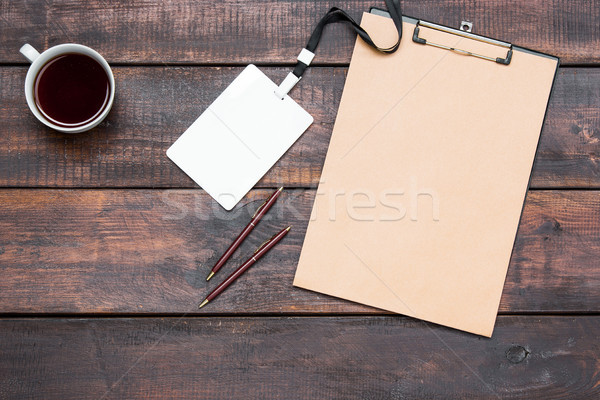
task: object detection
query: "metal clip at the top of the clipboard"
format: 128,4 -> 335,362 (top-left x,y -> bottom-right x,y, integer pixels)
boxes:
413,20 -> 512,65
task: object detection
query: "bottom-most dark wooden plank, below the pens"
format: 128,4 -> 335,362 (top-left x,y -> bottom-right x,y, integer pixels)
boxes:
0,316 -> 600,400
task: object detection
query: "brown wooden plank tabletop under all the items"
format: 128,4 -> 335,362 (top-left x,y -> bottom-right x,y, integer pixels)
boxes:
0,0 -> 600,399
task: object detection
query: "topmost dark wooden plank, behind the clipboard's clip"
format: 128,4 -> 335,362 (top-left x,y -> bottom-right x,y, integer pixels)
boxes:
0,0 -> 600,64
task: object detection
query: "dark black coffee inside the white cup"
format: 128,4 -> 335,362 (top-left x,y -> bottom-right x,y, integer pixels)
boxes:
34,53 -> 111,127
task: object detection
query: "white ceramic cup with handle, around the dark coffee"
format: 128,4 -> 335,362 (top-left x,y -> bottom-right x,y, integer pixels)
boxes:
20,43 -> 115,133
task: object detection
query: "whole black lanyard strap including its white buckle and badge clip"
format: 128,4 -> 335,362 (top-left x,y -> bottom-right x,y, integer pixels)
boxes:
275,0 -> 402,99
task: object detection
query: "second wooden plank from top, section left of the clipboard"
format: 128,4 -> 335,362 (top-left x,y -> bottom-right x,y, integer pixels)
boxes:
0,67 -> 346,187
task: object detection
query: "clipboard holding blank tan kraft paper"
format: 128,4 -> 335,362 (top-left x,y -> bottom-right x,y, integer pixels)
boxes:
294,9 -> 559,337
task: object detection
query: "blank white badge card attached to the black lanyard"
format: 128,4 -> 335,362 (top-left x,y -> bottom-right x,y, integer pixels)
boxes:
167,65 -> 313,210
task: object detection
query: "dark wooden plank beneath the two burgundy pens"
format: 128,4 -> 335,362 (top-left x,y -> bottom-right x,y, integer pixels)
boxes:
0,189 -> 600,314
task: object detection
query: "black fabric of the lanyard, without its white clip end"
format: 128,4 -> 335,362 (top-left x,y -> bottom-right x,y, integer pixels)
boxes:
292,0 -> 402,79
